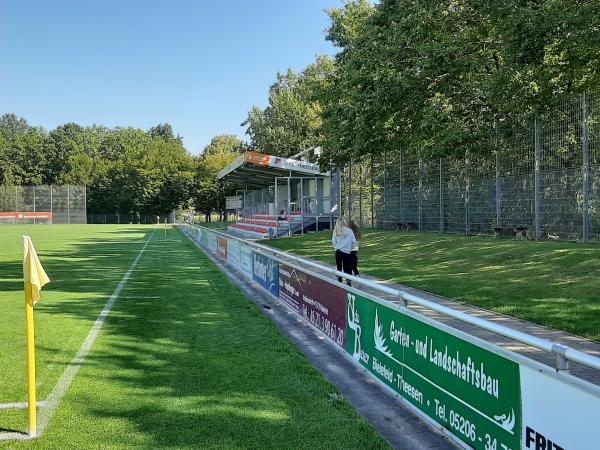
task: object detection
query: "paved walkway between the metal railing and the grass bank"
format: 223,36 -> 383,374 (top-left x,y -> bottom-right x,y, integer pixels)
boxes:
258,241 -> 600,385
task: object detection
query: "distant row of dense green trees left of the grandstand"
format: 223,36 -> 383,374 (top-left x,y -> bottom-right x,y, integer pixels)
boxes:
0,114 -> 195,214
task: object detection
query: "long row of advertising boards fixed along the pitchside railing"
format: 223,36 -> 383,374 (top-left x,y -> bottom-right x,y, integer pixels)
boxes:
185,229 -> 600,450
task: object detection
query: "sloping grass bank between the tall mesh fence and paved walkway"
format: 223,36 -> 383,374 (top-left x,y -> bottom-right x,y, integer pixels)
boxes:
264,230 -> 600,341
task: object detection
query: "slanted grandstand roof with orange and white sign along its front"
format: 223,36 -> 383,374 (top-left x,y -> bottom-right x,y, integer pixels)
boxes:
219,152 -> 321,187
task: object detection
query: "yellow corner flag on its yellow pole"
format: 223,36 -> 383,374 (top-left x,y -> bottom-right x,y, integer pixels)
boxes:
23,236 -> 50,437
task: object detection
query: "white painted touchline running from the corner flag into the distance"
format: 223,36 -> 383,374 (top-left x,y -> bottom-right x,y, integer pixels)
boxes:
0,228 -> 156,441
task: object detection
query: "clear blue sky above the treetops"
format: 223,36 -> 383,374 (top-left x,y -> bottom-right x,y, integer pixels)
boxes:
0,0 -> 342,153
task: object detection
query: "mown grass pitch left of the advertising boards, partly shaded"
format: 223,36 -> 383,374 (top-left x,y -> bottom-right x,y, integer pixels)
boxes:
0,225 -> 386,449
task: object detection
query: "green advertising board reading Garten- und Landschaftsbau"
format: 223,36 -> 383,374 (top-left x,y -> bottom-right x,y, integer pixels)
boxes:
346,292 -> 521,450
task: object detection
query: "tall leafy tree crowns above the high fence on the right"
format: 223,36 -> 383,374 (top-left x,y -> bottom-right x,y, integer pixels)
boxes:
245,0 -> 600,163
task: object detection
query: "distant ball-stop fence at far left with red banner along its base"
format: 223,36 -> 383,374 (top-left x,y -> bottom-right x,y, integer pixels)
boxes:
0,185 -> 86,224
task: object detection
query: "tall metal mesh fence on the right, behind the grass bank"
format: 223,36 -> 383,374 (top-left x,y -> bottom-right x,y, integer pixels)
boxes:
341,92 -> 600,241
